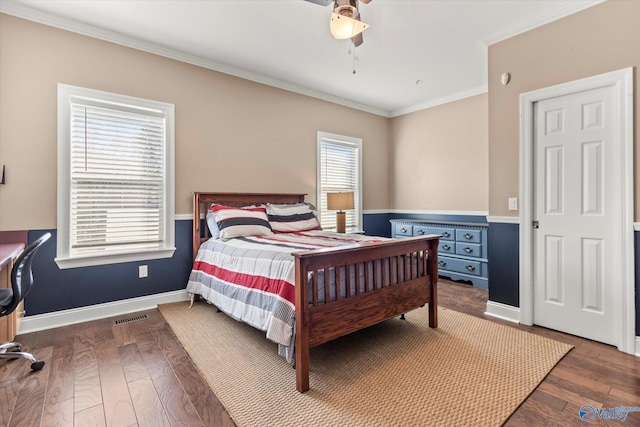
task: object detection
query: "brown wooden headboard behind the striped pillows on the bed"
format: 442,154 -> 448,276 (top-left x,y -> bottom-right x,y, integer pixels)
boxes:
193,192 -> 306,259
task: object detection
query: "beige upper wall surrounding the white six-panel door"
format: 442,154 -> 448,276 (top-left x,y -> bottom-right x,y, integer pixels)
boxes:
489,0 -> 640,221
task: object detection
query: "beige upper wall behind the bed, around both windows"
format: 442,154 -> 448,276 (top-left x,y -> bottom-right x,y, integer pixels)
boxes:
0,14 -> 390,230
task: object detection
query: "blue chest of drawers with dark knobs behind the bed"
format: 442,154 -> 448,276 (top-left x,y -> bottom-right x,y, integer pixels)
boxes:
391,219 -> 489,289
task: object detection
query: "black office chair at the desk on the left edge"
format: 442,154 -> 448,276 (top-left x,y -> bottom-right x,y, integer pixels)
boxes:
0,233 -> 51,371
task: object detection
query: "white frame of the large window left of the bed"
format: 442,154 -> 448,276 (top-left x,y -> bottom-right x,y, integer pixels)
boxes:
55,83 -> 176,269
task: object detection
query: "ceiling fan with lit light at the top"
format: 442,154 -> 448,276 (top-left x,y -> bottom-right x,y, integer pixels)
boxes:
305,0 -> 371,46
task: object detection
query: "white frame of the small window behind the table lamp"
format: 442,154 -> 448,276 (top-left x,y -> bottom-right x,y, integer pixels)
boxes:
316,131 -> 363,233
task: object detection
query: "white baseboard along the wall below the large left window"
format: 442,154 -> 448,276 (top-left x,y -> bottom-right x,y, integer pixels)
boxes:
18,290 -> 189,334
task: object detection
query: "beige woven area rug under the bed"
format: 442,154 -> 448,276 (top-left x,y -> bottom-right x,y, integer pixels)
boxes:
159,302 -> 572,427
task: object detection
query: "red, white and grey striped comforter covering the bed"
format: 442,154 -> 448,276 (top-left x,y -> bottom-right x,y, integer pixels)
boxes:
187,230 -> 382,362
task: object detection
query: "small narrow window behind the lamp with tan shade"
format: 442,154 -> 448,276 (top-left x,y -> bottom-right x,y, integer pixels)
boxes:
317,132 -> 362,231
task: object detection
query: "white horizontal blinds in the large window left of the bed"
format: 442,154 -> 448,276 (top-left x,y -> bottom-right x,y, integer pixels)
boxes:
71,102 -> 164,255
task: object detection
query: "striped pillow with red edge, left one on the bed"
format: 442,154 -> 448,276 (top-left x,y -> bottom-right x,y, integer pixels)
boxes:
211,204 -> 273,240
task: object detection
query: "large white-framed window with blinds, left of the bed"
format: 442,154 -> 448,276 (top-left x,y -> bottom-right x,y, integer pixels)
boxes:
56,84 -> 175,268
